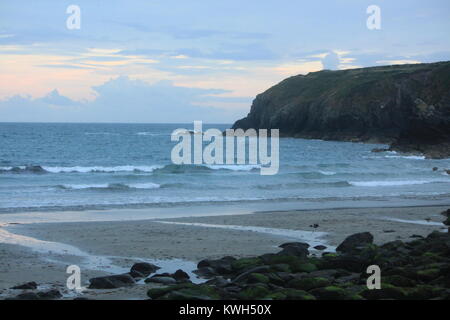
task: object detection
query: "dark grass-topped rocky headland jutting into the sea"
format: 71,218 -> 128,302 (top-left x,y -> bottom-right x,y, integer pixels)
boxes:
233,62 -> 450,157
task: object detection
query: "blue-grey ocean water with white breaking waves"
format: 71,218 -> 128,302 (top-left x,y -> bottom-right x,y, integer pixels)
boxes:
0,123 -> 450,213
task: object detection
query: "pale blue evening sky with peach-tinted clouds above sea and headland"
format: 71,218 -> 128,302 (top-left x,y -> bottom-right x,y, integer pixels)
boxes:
0,0 -> 450,123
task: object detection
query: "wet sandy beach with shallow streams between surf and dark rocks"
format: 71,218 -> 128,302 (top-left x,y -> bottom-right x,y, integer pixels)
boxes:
0,206 -> 448,299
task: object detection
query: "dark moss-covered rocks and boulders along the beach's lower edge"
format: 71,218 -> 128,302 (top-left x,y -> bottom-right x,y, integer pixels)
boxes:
9,209 -> 450,300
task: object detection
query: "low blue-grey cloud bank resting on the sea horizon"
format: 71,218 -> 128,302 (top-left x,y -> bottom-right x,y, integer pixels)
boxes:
0,76 -> 249,123
